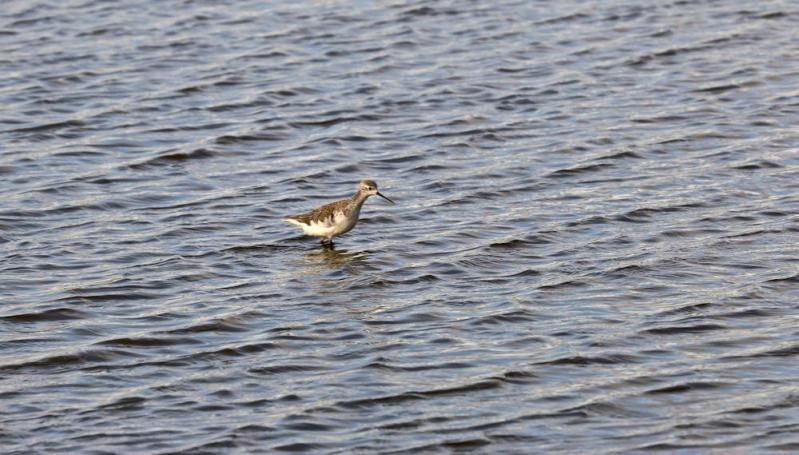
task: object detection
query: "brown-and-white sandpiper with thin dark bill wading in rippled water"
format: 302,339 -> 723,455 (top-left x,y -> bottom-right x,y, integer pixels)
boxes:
284,180 -> 394,246
